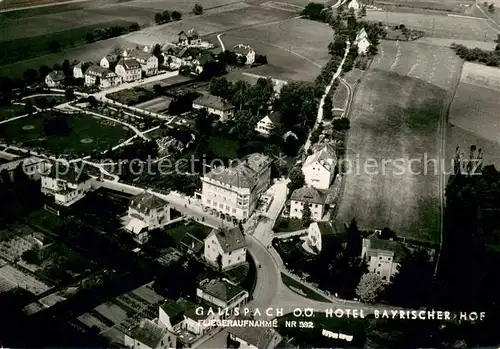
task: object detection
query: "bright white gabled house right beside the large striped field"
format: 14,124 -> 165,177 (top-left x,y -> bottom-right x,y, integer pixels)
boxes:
302,144 -> 337,190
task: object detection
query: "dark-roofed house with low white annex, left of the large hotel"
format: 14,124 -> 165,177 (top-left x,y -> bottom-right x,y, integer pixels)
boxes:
125,192 -> 170,244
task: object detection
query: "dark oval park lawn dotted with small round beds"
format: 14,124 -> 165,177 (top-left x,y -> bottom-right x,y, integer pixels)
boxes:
0,114 -> 131,153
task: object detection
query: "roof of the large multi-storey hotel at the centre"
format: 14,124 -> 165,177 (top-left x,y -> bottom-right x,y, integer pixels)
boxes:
207,153 -> 272,188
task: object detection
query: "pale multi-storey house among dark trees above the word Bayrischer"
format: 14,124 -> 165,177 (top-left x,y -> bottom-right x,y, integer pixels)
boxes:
361,232 -> 408,283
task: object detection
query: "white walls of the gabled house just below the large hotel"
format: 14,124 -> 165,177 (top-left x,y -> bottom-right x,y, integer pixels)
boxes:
203,230 -> 247,270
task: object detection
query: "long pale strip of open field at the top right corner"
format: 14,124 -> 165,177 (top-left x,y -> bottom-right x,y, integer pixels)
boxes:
365,11 -> 497,41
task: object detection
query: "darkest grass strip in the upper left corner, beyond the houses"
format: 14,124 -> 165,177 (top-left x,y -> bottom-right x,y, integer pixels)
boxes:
0,20 -> 132,64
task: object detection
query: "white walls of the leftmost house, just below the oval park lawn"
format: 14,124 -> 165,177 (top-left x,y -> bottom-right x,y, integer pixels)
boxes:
41,175 -> 92,206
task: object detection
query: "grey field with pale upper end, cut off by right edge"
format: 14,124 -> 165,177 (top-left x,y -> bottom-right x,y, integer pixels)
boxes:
448,62 -> 500,167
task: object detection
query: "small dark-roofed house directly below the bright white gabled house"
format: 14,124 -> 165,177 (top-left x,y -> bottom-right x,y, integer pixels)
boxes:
290,185 -> 326,221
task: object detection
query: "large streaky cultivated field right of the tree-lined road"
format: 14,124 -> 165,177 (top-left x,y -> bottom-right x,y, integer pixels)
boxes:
338,42 -> 460,241
